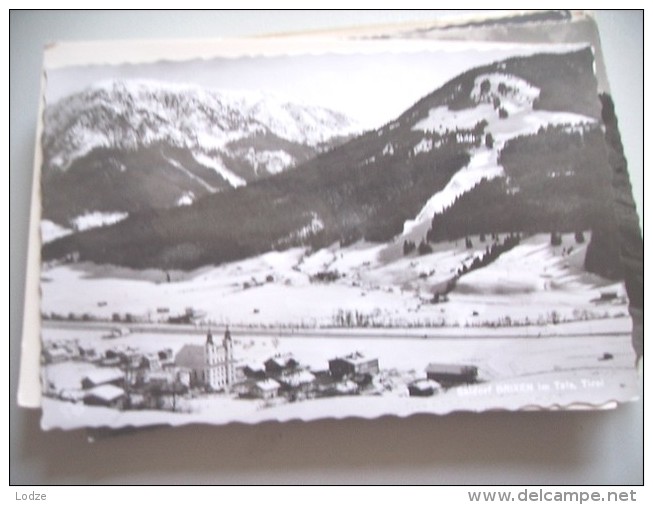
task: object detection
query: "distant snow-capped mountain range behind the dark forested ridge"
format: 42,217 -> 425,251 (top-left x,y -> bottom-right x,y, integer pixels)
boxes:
43,80 -> 360,224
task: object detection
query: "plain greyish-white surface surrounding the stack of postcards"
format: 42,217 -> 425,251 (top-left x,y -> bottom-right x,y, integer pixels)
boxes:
9,11 -> 643,484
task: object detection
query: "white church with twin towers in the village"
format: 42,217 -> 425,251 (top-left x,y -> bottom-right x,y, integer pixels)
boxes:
175,327 -> 235,391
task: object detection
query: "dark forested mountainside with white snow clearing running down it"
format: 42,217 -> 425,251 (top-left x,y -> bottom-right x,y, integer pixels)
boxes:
44,50 -> 610,278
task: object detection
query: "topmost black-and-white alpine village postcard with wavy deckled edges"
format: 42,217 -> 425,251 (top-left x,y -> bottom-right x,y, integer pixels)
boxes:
33,38 -> 643,429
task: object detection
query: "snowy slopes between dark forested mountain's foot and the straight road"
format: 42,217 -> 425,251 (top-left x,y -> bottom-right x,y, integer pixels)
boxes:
41,234 -> 631,334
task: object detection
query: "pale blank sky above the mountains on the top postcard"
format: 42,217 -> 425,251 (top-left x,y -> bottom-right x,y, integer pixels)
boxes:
46,41 -> 579,128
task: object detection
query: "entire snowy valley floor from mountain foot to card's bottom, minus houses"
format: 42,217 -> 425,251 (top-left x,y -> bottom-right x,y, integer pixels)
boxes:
41,228 -> 637,429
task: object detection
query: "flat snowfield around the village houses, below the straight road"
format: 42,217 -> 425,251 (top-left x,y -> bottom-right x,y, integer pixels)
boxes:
42,325 -> 637,429
